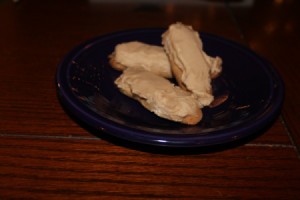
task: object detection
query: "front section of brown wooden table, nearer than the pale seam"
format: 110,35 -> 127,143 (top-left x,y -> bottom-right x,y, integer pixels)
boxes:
0,137 -> 300,198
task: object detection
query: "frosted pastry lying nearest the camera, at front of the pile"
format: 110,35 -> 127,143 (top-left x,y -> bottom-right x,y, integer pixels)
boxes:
115,68 -> 202,125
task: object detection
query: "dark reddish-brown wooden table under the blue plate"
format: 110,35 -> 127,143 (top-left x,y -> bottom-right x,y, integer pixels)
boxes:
0,0 -> 300,199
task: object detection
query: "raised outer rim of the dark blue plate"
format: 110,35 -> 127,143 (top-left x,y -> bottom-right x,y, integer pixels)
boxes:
55,28 -> 284,147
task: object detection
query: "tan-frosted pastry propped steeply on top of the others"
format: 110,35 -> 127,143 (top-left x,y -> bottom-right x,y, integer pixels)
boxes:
162,23 -> 217,107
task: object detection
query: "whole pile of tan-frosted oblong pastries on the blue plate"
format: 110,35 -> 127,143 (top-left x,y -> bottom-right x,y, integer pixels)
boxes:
109,23 -> 222,125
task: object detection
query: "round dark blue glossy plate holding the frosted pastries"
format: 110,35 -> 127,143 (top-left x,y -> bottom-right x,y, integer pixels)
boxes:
56,29 -> 284,147
